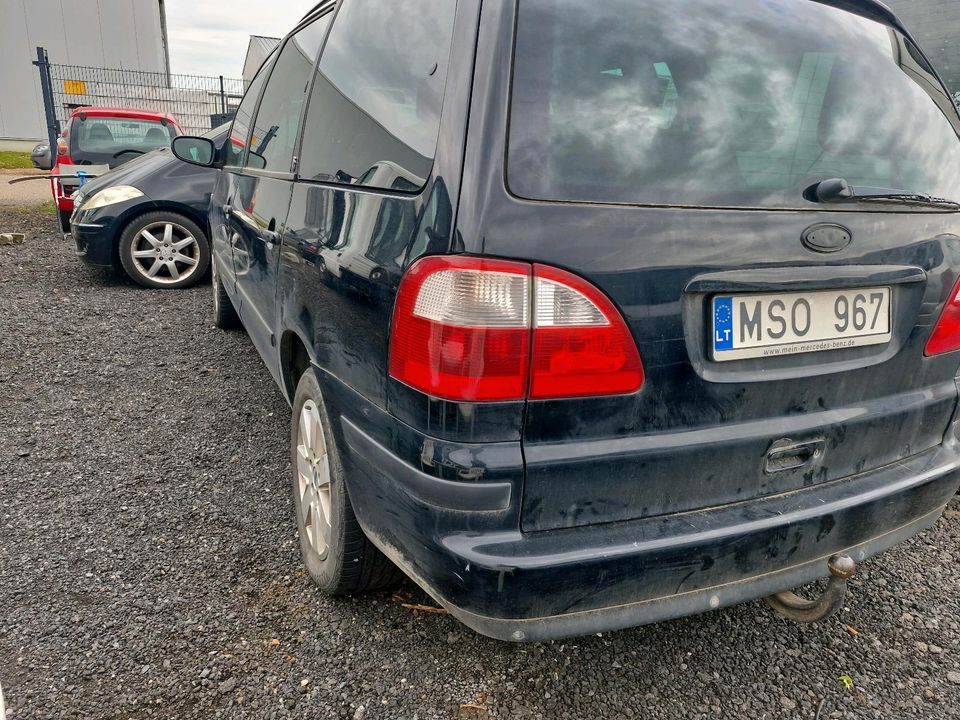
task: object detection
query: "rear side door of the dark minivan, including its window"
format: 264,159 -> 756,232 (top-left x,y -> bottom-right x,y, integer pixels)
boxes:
225,13 -> 330,374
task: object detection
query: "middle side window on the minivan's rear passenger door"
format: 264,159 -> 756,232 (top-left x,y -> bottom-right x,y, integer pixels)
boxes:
245,14 -> 331,172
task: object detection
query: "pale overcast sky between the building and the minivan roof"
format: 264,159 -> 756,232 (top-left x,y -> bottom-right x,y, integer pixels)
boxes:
166,0 -> 317,78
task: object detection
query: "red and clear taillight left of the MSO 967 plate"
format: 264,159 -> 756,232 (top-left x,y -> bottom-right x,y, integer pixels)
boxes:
390,256 -> 643,402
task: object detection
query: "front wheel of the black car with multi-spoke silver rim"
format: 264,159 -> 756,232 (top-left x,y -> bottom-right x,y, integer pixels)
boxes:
118,210 -> 210,290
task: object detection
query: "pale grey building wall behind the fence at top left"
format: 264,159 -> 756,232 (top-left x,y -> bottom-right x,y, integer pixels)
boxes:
0,0 -> 168,139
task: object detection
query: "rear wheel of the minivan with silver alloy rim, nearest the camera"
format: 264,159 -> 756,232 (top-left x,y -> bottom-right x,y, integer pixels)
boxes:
290,370 -> 403,595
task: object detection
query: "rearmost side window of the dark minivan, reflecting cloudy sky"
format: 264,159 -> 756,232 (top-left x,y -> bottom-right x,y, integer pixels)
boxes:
300,0 -> 456,189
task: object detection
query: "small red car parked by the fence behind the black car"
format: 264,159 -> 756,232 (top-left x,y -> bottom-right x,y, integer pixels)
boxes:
51,107 -> 183,232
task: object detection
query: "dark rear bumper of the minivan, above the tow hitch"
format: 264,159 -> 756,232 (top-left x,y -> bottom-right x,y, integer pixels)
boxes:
335,372 -> 960,641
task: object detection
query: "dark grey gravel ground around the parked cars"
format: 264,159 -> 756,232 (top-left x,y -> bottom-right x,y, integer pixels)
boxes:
0,204 -> 960,720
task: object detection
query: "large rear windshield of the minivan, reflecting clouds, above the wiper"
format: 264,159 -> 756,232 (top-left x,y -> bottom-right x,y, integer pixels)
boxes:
508,0 -> 960,208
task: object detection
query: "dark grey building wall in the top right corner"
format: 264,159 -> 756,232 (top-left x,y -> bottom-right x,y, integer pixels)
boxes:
886,0 -> 960,92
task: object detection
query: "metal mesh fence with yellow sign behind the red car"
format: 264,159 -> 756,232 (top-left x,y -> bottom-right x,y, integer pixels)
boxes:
40,56 -> 245,134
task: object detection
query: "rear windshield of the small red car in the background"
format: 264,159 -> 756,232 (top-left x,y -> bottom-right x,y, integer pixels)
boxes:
70,117 -> 176,162
